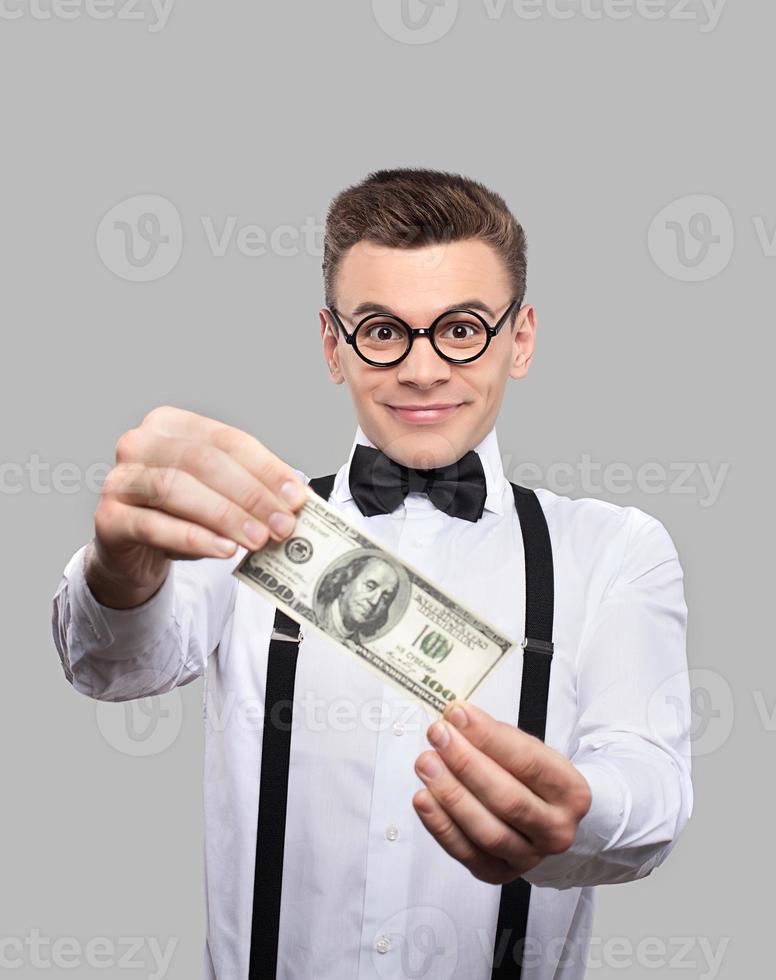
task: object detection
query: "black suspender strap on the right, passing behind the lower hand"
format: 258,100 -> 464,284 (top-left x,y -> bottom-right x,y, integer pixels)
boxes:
491,483 -> 554,980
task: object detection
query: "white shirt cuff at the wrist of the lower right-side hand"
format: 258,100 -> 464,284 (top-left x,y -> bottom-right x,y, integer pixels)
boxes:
522,762 -> 630,888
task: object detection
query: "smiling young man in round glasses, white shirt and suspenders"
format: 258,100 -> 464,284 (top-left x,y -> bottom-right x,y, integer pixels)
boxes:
54,170 -> 692,980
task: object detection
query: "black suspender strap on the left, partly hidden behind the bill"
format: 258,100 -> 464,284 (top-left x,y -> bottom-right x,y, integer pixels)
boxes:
248,474 -> 336,980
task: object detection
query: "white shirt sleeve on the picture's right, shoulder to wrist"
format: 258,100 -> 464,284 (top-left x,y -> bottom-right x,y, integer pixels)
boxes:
523,508 -> 693,889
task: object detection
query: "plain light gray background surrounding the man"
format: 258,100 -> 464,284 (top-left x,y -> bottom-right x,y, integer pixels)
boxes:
0,0 -> 776,980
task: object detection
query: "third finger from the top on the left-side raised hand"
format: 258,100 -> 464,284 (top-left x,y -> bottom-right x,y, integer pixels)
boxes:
104,464 -> 278,551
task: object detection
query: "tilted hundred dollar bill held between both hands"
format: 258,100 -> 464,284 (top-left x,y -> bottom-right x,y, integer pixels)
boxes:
233,487 -> 515,712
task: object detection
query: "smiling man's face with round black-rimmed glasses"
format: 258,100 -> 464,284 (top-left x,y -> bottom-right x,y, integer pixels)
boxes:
320,239 -> 536,469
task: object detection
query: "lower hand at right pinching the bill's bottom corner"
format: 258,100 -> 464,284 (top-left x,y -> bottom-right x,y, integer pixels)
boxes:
412,701 -> 592,885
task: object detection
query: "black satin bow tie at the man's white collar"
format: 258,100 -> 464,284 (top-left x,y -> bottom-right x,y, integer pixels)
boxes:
348,444 -> 487,521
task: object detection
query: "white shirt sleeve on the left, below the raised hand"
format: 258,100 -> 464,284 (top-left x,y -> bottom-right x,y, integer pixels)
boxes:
52,470 -> 307,701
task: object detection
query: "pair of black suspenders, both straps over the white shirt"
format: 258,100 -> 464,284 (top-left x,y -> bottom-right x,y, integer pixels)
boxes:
248,474 -> 554,980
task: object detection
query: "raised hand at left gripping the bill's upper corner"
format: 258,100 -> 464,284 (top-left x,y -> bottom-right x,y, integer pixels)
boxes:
85,406 -> 307,609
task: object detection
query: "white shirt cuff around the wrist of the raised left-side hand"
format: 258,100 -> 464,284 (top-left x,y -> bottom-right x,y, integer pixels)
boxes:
64,545 -> 175,659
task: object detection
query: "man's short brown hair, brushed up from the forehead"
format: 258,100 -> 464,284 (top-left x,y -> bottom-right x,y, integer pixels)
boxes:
323,167 -> 526,325
